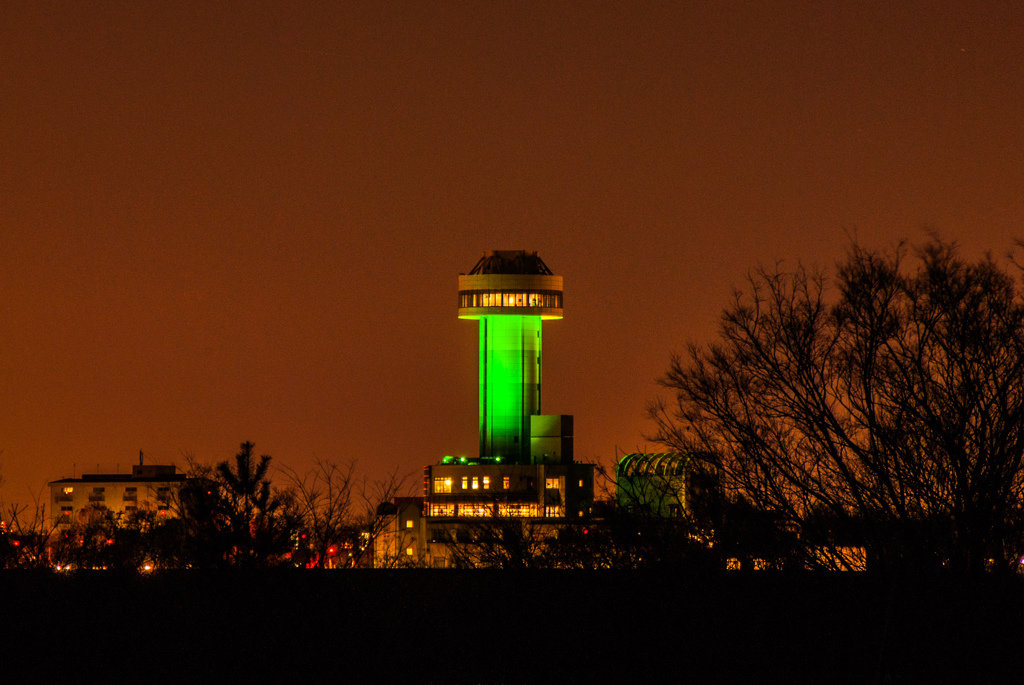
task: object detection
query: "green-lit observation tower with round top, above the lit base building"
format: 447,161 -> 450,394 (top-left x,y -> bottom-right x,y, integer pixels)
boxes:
459,250 -> 572,464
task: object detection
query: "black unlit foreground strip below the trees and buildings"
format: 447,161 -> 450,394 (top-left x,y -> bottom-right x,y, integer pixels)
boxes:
0,570 -> 1024,683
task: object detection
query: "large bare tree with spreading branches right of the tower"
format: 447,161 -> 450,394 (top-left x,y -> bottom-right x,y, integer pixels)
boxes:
651,238 -> 1024,571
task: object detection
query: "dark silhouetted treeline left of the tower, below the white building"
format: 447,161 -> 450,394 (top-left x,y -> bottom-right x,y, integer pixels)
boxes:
0,442 -> 402,571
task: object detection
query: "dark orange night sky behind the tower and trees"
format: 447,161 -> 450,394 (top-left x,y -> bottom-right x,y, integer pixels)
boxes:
0,0 -> 1024,503
